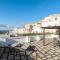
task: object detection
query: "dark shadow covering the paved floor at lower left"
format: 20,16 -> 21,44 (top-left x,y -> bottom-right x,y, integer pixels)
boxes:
0,46 -> 35,60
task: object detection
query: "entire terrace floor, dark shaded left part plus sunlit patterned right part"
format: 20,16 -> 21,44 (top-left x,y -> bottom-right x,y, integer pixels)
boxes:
0,40 -> 60,60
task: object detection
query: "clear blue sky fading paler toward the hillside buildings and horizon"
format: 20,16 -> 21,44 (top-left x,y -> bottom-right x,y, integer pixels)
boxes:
0,0 -> 60,29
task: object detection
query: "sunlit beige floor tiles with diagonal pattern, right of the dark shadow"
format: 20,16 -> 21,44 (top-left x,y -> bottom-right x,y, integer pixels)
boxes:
32,41 -> 60,60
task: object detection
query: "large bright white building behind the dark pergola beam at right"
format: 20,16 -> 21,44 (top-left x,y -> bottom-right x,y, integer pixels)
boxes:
41,14 -> 60,33
